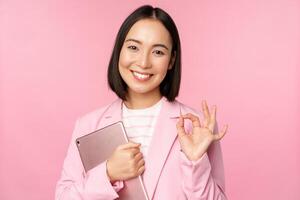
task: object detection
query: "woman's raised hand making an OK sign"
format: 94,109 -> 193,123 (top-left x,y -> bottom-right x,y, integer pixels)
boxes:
176,101 -> 228,161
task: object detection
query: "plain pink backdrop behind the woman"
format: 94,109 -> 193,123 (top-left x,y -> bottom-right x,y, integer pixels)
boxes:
0,0 -> 300,200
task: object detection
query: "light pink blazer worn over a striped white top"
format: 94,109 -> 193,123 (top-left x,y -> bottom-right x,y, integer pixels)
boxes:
55,97 -> 227,200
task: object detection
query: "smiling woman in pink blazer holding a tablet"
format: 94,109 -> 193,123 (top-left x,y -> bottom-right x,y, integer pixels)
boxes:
56,6 -> 227,200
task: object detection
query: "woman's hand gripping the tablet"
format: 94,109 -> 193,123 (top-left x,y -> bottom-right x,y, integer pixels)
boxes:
106,142 -> 145,183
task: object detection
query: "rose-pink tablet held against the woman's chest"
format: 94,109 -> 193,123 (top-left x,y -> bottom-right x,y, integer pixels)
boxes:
76,121 -> 148,200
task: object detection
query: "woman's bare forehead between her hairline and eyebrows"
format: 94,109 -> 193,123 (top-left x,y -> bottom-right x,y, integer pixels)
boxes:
125,19 -> 172,45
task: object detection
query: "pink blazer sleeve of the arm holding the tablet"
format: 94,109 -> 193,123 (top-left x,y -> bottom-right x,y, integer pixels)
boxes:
55,119 -> 123,200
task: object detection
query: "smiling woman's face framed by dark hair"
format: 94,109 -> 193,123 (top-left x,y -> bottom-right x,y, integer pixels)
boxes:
119,19 -> 175,97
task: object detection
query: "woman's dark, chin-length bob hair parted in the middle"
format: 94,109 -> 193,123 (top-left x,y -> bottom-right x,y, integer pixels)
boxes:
107,5 -> 181,102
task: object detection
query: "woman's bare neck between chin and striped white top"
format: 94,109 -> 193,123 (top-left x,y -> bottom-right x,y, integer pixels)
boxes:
124,93 -> 162,109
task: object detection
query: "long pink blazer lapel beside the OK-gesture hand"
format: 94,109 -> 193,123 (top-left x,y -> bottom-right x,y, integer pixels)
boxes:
143,97 -> 181,199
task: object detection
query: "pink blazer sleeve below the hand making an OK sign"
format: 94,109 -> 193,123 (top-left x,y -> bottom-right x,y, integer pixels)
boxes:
180,121 -> 227,200
